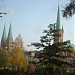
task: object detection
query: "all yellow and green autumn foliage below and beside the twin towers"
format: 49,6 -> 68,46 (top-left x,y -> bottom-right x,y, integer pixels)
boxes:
0,34 -> 27,69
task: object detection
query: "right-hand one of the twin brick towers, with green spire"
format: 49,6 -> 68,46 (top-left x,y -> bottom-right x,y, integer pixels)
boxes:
7,23 -> 13,50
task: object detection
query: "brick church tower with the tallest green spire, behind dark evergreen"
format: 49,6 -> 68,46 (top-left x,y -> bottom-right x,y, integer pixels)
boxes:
54,5 -> 64,43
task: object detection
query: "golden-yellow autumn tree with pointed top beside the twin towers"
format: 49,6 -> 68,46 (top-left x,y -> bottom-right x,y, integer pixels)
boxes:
11,35 -> 27,69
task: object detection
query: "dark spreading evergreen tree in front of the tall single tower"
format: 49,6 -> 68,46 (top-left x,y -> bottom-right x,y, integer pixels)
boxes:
31,24 -> 73,68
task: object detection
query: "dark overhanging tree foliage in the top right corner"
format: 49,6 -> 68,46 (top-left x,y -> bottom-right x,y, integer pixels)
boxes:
62,0 -> 75,17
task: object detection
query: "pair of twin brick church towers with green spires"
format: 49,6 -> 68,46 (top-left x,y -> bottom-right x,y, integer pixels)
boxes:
1,24 -> 13,50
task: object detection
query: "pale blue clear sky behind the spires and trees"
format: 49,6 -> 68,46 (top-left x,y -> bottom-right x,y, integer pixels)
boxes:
0,0 -> 75,50
